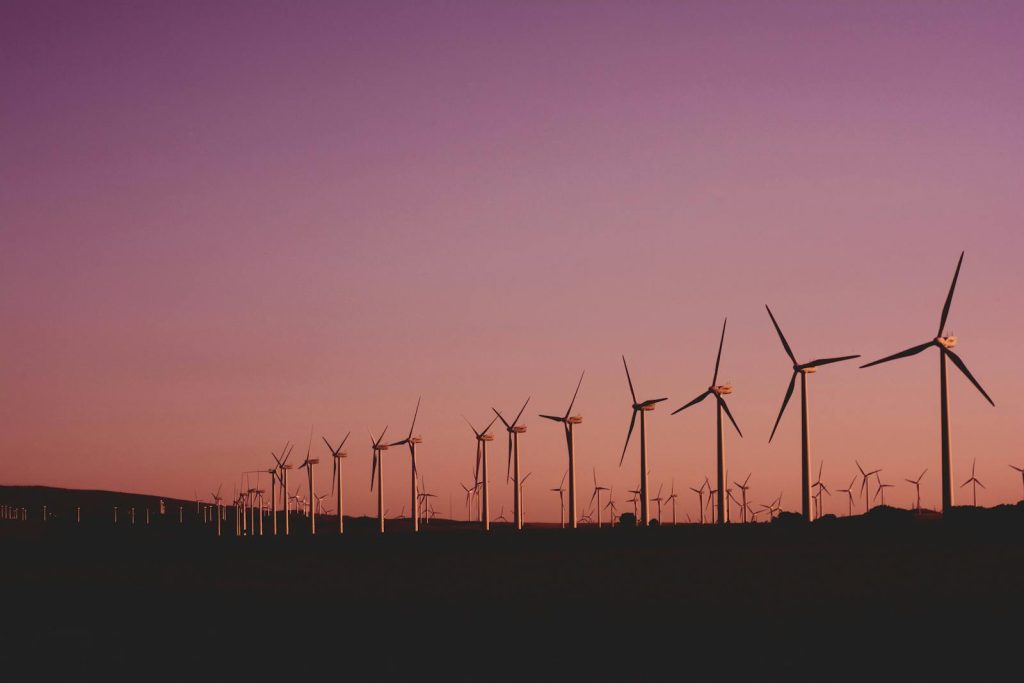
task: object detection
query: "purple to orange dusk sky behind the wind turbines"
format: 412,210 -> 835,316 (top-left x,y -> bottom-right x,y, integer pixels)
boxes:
0,1 -> 1024,521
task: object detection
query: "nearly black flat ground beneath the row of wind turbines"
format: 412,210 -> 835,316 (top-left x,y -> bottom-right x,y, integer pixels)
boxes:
0,489 -> 1024,680
